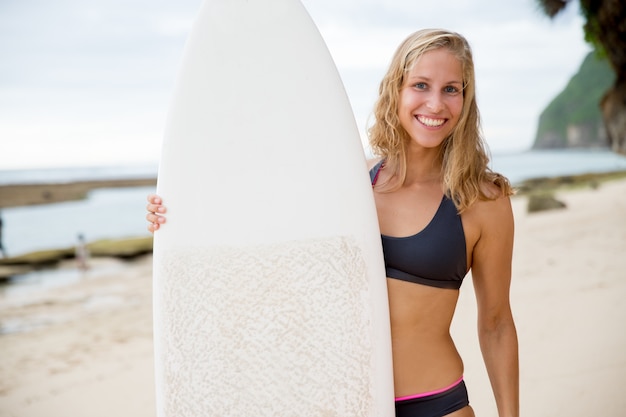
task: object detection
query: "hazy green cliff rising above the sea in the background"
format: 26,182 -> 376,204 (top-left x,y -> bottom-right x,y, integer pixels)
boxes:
532,51 -> 615,149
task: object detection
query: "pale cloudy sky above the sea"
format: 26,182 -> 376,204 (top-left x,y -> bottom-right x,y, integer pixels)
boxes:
0,0 -> 591,171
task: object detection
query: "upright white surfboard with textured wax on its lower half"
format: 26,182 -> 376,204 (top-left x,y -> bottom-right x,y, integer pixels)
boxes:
153,0 -> 394,417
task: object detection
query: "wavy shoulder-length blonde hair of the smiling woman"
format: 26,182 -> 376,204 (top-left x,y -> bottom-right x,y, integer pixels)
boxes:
369,29 -> 514,212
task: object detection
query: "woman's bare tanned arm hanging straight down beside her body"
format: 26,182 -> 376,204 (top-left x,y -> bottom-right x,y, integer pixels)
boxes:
472,193 -> 519,417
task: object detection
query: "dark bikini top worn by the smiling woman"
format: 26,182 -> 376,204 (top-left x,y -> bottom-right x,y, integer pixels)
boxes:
370,161 -> 467,289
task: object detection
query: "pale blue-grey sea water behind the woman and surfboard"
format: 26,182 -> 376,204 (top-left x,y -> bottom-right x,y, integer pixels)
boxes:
0,146 -> 626,255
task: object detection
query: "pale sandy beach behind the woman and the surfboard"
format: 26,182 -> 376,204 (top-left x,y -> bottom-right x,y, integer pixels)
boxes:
0,180 -> 626,417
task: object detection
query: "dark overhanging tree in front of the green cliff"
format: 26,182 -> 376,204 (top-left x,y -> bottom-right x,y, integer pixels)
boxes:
536,0 -> 626,155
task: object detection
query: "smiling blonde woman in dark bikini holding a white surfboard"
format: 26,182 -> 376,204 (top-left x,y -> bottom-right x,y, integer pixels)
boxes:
147,29 -> 519,417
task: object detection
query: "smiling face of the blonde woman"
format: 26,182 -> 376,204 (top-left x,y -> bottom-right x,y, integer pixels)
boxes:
398,48 -> 463,148
